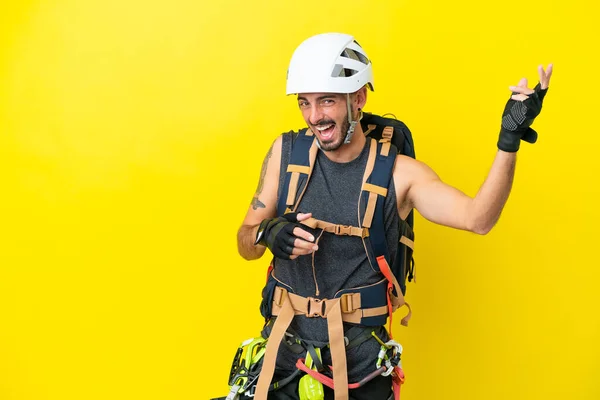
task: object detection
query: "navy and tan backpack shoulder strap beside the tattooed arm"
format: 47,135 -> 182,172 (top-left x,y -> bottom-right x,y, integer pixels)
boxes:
277,128 -> 318,215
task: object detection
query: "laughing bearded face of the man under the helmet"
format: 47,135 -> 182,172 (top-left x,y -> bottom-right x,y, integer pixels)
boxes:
298,93 -> 350,151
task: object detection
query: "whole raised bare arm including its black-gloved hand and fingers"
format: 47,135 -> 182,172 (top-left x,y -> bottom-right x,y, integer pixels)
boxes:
394,64 -> 552,234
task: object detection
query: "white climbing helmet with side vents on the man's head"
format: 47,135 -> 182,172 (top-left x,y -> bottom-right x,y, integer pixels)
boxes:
286,33 -> 373,95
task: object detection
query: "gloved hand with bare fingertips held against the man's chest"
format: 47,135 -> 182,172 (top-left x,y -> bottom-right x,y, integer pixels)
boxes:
254,213 -> 319,260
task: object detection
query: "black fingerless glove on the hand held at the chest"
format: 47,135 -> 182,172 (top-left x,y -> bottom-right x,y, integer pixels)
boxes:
254,213 -> 301,260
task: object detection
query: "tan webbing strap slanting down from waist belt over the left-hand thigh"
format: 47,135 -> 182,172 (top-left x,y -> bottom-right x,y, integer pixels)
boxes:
254,298 -> 294,400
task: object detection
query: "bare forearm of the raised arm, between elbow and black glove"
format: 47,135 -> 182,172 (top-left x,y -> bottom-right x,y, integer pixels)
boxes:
468,150 -> 517,234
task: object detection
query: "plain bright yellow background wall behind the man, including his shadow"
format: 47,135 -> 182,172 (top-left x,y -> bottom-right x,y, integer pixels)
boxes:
0,0 -> 600,400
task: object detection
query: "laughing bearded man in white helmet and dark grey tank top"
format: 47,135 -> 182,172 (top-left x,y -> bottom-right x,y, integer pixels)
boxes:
238,33 -> 552,400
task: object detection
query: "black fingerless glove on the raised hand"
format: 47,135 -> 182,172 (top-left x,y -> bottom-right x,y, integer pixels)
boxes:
498,83 -> 548,153
